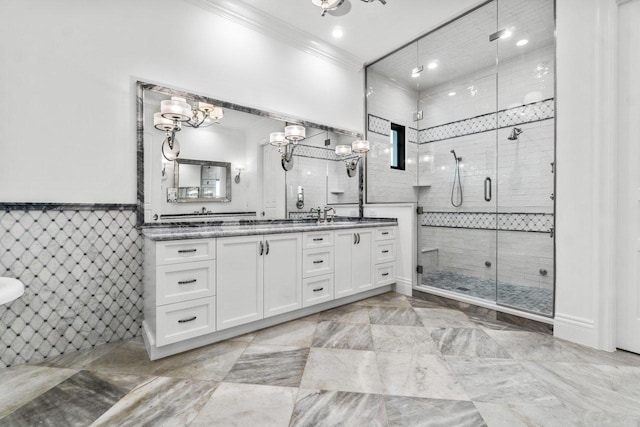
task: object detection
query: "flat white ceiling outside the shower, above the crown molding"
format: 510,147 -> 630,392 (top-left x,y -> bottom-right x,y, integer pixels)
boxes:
186,0 -> 483,67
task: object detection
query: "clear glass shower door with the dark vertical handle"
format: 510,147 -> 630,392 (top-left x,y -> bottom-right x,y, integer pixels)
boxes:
416,2 -> 497,302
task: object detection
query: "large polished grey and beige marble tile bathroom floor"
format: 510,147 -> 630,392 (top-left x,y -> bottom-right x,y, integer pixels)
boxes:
0,293 -> 640,426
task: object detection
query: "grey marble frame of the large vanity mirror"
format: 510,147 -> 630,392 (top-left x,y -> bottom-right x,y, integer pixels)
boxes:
136,80 -> 364,227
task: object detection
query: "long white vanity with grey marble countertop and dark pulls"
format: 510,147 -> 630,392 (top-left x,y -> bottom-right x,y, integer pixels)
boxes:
142,218 -> 398,360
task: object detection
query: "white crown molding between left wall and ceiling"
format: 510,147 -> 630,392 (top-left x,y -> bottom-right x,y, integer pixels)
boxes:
184,0 -> 364,71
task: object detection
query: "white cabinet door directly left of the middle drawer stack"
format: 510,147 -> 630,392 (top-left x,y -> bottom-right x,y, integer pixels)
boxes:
264,233 -> 302,317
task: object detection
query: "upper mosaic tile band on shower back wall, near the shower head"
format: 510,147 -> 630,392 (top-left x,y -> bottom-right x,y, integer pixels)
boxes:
418,98 -> 555,144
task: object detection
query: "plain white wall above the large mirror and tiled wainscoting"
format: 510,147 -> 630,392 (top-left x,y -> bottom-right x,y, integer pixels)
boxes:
0,0 -> 363,203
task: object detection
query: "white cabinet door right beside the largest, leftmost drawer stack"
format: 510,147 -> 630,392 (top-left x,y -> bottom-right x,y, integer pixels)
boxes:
216,236 -> 264,331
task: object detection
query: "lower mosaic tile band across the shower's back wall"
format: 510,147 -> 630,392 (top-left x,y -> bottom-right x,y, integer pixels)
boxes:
420,212 -> 554,233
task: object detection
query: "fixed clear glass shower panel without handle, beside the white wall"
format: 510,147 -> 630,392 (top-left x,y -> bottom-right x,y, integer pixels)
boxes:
496,0 -> 555,316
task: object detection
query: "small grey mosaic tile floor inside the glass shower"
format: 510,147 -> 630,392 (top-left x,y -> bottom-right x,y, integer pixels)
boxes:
422,270 -> 553,316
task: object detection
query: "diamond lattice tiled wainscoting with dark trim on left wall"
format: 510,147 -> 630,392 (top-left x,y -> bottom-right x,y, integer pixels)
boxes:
0,204 -> 143,367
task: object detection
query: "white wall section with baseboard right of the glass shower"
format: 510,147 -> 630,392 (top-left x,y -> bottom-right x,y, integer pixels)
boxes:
554,0 -> 617,350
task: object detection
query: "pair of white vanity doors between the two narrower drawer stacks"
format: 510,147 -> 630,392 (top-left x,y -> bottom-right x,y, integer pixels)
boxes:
335,228 -> 375,298
